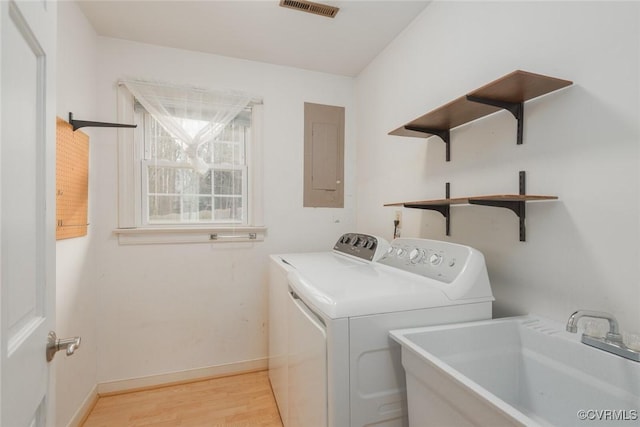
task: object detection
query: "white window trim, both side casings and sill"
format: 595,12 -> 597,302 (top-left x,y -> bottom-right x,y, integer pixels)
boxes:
113,83 -> 267,244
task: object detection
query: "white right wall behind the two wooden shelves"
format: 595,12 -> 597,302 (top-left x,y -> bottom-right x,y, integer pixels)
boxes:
356,2 -> 640,333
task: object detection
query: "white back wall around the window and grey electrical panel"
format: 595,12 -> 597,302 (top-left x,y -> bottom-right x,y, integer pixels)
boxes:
92,38 -> 355,382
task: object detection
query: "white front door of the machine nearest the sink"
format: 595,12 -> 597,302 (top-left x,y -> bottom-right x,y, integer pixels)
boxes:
286,290 -> 327,427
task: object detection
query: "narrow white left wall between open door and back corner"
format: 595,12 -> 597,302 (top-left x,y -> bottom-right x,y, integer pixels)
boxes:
53,1 -> 97,426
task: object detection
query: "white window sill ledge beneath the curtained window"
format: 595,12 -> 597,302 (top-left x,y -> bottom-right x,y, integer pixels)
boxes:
113,226 -> 267,245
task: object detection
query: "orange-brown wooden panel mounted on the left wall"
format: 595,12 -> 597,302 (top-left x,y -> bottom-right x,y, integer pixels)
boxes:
56,117 -> 89,240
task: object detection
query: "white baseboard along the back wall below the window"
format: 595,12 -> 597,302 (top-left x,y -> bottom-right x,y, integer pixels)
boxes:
97,357 -> 269,396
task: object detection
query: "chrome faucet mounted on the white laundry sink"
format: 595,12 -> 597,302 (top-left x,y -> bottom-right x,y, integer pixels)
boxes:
567,310 -> 640,362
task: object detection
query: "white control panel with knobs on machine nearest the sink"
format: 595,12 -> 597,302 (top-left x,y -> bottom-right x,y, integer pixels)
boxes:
378,238 -> 471,283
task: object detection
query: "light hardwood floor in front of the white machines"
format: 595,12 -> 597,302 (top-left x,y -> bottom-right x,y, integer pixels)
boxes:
83,371 -> 282,427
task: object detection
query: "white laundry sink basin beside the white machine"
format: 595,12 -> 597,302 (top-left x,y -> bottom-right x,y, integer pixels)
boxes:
391,316 -> 640,427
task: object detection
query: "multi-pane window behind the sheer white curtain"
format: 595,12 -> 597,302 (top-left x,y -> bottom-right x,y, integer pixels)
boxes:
141,105 -> 251,224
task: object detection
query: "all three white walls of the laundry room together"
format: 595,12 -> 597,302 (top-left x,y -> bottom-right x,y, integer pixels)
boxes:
54,2 -> 640,425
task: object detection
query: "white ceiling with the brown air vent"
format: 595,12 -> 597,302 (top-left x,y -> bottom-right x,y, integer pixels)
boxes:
78,0 -> 429,76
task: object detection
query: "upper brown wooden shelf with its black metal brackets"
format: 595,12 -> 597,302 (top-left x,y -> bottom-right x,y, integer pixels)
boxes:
389,70 -> 573,161
